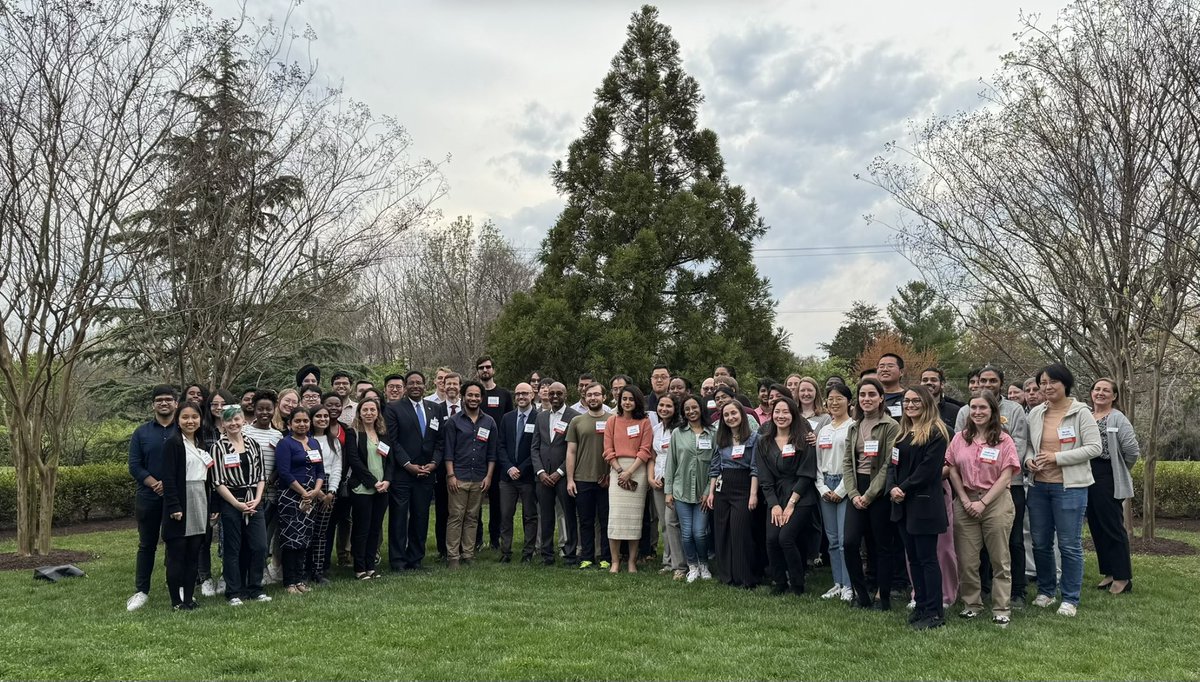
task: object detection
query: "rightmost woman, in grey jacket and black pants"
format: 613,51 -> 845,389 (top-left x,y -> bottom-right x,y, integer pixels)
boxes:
1087,377 -> 1141,594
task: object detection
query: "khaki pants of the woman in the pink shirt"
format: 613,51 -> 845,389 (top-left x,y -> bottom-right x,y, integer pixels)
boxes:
954,491 -> 1016,616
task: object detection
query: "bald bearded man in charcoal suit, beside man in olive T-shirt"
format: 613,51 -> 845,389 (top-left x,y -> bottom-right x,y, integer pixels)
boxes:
526,382 -> 580,566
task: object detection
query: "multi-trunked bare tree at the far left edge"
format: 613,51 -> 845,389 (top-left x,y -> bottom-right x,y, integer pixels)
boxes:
0,0 -> 204,555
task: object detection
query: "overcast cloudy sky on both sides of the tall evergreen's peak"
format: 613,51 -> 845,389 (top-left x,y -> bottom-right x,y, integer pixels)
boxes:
238,0 -> 1064,354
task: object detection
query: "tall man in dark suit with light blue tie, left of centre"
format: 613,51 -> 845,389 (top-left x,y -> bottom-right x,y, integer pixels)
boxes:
383,370 -> 442,570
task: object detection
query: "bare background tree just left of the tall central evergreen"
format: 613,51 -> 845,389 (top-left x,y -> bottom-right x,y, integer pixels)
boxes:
356,216 -> 536,370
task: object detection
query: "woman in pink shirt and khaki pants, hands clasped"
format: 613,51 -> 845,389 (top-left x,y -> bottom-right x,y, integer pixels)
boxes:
946,390 -> 1025,627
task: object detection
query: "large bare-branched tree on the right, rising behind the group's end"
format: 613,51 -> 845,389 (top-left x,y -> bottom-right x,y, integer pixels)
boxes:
870,0 -> 1200,537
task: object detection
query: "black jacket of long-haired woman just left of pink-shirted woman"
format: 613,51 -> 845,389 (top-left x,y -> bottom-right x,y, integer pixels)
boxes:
880,431 -> 949,536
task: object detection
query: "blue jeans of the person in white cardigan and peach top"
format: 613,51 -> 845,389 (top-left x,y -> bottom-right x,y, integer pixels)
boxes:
1026,483 -> 1087,605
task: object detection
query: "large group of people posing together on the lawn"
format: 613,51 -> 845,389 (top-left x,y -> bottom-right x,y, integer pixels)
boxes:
127,353 -> 1139,629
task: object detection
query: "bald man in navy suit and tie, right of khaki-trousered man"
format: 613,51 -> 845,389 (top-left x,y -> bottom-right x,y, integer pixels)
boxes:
497,383 -> 538,563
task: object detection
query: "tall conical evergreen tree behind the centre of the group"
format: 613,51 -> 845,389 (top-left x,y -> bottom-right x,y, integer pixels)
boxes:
490,6 -> 791,383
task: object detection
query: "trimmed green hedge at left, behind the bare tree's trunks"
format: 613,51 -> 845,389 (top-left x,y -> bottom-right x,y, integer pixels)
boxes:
0,462 -> 137,528
